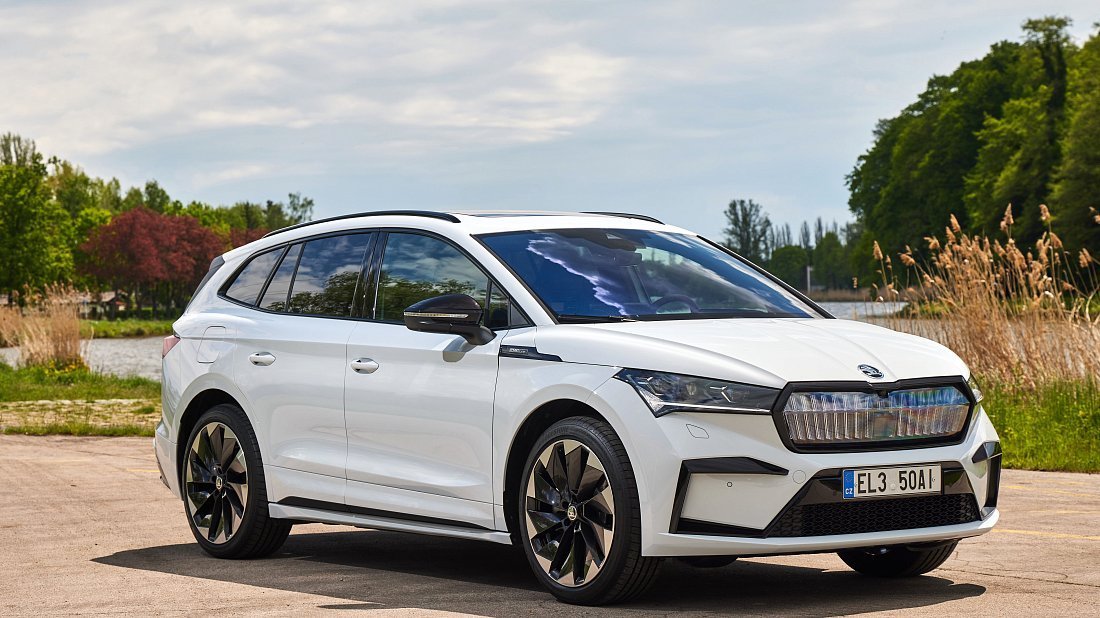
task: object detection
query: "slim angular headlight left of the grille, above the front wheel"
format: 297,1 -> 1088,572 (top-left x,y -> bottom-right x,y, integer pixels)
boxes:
615,369 -> 779,417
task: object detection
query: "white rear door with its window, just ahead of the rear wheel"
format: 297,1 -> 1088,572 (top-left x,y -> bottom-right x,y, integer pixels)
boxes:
227,233 -> 373,481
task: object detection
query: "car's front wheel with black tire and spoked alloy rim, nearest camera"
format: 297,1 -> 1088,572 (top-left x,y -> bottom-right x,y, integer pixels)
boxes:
517,417 -> 661,605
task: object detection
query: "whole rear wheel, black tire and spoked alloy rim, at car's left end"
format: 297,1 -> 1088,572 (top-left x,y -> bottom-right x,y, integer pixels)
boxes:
179,404 -> 292,559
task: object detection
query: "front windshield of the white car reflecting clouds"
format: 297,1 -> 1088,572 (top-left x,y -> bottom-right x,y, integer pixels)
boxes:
480,229 -> 816,322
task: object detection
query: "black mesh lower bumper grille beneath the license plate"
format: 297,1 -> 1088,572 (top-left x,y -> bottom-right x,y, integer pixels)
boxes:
768,494 -> 980,537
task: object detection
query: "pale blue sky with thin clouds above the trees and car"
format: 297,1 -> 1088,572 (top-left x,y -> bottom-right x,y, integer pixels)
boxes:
0,0 -> 1100,236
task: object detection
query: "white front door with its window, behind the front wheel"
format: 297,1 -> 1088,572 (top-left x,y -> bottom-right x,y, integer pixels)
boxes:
344,232 -> 502,527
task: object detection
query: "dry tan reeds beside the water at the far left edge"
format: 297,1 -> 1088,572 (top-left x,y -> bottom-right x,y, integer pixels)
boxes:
0,285 -> 87,371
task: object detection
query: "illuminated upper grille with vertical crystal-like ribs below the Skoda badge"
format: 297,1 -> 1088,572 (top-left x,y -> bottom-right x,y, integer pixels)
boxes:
783,386 -> 970,446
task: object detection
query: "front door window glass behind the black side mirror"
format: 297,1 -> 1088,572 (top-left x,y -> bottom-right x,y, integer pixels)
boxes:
375,233 -> 488,322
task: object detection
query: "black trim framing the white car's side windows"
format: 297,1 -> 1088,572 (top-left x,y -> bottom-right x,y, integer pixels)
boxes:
218,227 -> 532,332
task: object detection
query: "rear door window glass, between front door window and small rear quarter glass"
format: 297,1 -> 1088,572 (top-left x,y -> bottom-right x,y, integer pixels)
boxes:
286,234 -> 371,318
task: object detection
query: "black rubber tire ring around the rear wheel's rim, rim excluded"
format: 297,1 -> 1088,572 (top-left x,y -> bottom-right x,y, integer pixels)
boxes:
179,404 -> 267,558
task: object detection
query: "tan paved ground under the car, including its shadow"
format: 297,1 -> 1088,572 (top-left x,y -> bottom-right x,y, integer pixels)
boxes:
0,435 -> 1100,618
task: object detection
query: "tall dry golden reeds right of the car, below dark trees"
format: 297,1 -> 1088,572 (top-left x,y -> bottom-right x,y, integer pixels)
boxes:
875,206 -> 1100,387
